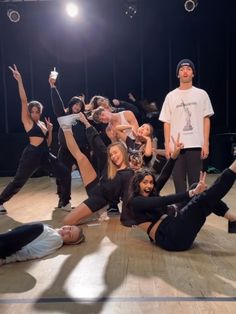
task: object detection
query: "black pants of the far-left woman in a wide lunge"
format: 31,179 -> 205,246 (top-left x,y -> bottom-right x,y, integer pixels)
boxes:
0,142 -> 71,205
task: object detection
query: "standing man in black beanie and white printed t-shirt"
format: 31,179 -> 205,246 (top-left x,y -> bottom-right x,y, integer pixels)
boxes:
159,59 -> 214,193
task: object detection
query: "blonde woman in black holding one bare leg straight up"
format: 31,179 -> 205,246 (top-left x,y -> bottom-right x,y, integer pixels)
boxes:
57,113 -> 133,225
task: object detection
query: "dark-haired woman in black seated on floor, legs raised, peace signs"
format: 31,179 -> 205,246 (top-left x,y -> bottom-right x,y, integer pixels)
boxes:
126,161 -> 236,251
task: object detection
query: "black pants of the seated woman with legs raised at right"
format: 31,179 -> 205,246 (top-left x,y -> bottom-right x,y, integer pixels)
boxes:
155,169 -> 236,251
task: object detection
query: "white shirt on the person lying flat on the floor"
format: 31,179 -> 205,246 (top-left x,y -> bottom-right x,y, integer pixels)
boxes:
5,225 -> 63,264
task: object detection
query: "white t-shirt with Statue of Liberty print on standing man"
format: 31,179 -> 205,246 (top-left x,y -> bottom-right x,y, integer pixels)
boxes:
159,86 -> 214,149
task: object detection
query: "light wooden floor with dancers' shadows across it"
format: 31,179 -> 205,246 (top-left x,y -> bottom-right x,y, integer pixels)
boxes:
0,175 -> 236,314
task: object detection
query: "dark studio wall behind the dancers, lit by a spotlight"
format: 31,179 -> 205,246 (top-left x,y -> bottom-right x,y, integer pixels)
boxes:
0,0 -> 236,175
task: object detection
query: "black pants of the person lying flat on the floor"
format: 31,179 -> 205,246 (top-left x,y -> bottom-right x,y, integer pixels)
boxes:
0,223 -> 44,258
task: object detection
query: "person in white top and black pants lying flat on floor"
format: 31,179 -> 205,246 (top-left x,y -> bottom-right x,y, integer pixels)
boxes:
0,223 -> 85,266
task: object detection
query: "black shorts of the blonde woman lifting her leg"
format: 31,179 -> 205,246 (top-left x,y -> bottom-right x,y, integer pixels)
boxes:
83,178 -> 109,213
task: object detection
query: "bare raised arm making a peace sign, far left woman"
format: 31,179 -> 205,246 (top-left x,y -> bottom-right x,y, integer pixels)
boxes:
9,64 -> 33,129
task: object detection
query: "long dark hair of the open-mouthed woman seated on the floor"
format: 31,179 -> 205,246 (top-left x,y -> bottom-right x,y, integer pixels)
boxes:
126,168 -> 156,205
